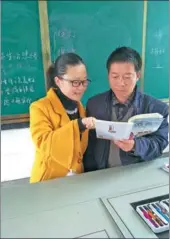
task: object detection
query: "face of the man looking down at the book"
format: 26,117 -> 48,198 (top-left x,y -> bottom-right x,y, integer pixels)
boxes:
108,62 -> 140,97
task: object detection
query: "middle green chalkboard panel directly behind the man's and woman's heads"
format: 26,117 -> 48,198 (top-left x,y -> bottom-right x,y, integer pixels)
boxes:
48,1 -> 143,103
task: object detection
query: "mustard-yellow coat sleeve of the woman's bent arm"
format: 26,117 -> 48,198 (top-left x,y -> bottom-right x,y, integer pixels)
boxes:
30,103 -> 80,169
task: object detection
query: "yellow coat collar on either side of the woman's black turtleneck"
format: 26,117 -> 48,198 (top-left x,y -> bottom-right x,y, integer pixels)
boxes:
47,88 -> 85,117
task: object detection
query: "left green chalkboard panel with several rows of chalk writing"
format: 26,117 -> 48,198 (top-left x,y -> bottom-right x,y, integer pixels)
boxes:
1,1 -> 45,116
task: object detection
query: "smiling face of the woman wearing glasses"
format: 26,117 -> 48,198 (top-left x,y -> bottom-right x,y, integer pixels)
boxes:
55,64 -> 88,101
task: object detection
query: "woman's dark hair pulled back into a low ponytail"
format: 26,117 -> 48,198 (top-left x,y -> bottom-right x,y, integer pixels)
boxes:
46,53 -> 84,90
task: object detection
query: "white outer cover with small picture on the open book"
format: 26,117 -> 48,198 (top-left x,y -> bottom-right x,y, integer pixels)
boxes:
95,120 -> 133,140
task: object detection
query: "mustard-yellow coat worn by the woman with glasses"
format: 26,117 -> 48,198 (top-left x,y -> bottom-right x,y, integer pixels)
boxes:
30,89 -> 88,183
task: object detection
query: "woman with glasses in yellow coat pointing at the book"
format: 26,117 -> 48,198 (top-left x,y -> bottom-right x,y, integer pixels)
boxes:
30,53 -> 94,183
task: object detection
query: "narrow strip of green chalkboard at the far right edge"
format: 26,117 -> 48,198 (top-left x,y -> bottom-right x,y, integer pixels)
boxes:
144,1 -> 169,99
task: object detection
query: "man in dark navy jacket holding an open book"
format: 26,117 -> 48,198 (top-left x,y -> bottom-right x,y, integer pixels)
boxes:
84,47 -> 168,172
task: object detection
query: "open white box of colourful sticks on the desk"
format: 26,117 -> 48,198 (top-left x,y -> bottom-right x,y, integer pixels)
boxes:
136,199 -> 169,233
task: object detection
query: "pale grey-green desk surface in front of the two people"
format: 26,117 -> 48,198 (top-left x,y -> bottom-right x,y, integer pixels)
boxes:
1,158 -> 169,238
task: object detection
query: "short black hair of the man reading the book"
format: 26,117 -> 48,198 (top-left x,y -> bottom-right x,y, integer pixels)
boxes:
106,46 -> 142,72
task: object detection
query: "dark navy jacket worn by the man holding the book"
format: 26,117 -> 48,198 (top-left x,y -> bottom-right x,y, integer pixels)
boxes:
83,88 -> 168,172
